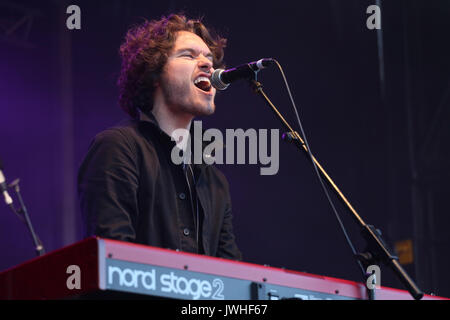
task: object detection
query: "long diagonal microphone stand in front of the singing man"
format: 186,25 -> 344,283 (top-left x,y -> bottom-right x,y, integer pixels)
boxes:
250,79 -> 423,300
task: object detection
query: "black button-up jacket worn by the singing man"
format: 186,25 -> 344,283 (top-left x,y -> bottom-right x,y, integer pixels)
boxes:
78,112 -> 242,260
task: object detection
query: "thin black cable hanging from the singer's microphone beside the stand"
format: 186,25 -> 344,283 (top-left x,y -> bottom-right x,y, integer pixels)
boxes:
274,59 -> 366,277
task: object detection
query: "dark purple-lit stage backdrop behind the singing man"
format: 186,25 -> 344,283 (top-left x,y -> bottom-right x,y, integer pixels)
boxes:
0,0 -> 450,297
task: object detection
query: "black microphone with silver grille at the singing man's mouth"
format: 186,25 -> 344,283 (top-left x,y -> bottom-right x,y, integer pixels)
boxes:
211,58 -> 275,90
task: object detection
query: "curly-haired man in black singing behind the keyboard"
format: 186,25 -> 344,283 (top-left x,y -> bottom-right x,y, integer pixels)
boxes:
78,14 -> 242,260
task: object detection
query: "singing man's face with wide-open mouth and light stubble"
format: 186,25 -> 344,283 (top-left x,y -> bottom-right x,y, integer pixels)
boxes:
159,31 -> 216,117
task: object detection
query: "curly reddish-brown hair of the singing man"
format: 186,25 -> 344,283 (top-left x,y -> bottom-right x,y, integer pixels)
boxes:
117,14 -> 226,118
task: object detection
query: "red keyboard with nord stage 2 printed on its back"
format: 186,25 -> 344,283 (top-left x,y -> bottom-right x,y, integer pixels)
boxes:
0,237 -> 446,300
